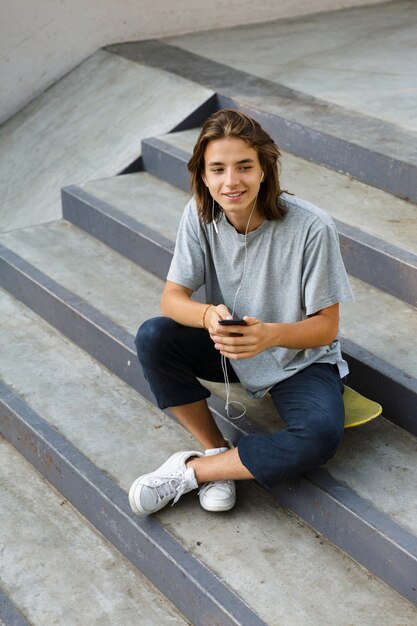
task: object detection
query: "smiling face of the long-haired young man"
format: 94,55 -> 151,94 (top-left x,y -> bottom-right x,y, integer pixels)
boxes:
203,137 -> 263,232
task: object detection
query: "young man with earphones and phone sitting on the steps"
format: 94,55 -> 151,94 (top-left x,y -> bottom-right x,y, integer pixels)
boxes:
129,110 -> 352,514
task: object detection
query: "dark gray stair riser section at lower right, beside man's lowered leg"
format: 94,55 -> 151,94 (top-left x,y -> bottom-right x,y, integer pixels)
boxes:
272,469 -> 417,604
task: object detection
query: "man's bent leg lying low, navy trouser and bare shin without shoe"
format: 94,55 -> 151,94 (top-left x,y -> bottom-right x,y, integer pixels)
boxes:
187,364 -> 344,487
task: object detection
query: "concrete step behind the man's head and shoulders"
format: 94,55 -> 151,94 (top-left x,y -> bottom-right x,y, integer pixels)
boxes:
139,128 -> 417,306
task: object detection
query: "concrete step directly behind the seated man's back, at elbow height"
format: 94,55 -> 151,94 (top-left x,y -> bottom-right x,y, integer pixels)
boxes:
61,171 -> 417,434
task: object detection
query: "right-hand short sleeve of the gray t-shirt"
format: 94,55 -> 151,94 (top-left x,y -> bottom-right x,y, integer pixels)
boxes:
302,219 -> 353,316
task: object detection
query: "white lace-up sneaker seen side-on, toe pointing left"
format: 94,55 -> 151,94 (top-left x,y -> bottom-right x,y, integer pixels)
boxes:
129,451 -> 204,515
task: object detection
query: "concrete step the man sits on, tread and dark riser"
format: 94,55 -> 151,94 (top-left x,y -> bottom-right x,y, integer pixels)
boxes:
0,218 -> 417,601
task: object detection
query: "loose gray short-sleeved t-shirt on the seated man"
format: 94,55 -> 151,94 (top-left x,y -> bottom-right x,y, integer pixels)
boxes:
167,194 -> 352,397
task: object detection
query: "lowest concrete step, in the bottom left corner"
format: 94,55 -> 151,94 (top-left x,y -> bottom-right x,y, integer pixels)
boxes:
0,434 -> 190,626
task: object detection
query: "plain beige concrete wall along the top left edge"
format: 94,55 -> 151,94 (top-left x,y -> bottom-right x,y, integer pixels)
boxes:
0,0 -> 383,123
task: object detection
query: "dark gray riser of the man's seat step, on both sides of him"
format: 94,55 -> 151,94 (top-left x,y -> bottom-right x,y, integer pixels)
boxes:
1,245 -> 417,610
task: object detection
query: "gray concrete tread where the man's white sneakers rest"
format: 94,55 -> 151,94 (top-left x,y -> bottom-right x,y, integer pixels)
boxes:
0,294 -> 417,626
